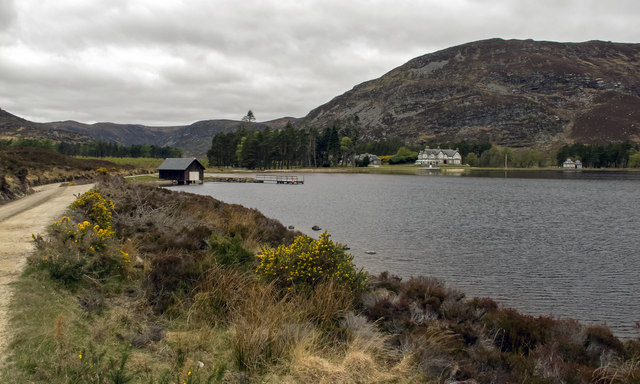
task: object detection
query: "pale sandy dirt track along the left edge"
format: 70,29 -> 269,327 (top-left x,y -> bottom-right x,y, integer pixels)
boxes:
0,184 -> 93,366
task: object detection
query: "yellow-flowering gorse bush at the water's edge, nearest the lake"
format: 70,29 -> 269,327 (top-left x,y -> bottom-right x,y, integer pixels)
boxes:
256,232 -> 367,291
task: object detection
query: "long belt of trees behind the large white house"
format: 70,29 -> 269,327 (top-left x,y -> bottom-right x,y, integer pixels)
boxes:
207,121 -> 555,169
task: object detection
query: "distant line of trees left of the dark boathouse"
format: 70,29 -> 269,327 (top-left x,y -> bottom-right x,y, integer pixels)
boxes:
0,139 -> 182,158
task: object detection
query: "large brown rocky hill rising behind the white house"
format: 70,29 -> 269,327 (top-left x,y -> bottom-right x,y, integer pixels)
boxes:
304,39 -> 640,149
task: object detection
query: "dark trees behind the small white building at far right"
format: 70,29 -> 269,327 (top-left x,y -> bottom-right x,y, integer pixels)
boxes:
556,141 -> 640,168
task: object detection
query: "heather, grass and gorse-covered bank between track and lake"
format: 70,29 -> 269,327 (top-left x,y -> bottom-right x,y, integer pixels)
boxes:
3,178 -> 640,383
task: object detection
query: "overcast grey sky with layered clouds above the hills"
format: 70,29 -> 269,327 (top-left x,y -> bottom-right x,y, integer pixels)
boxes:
0,0 -> 640,126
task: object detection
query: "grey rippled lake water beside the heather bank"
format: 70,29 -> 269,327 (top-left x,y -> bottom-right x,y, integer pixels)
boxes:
169,172 -> 640,337
